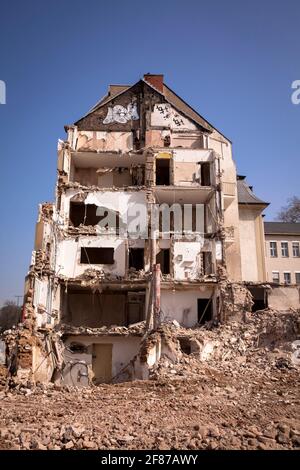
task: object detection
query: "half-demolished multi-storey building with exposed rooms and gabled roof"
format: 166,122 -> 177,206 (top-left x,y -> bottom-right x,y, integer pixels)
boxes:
7,74 -> 300,386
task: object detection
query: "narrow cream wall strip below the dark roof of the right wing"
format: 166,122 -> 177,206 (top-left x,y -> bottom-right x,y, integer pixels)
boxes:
239,209 -> 259,281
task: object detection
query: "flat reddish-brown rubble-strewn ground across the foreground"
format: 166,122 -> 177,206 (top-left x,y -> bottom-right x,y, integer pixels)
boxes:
0,367 -> 300,449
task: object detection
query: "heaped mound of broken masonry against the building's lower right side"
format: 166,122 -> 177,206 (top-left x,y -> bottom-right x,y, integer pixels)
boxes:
151,310 -> 300,379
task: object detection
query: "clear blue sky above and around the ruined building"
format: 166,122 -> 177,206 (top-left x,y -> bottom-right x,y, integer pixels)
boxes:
0,0 -> 300,304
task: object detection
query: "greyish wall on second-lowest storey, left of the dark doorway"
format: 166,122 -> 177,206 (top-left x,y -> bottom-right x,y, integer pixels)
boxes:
161,287 -> 212,328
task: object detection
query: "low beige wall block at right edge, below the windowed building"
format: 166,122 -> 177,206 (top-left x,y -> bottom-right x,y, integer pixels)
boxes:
268,286 -> 300,311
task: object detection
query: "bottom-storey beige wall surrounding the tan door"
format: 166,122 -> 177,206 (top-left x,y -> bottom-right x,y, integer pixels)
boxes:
66,336 -> 141,380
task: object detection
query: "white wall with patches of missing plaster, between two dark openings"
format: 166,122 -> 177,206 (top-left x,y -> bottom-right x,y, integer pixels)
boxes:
174,239 -> 204,280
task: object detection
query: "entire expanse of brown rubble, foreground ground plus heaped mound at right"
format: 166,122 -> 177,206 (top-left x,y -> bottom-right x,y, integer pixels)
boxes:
0,310 -> 300,449
